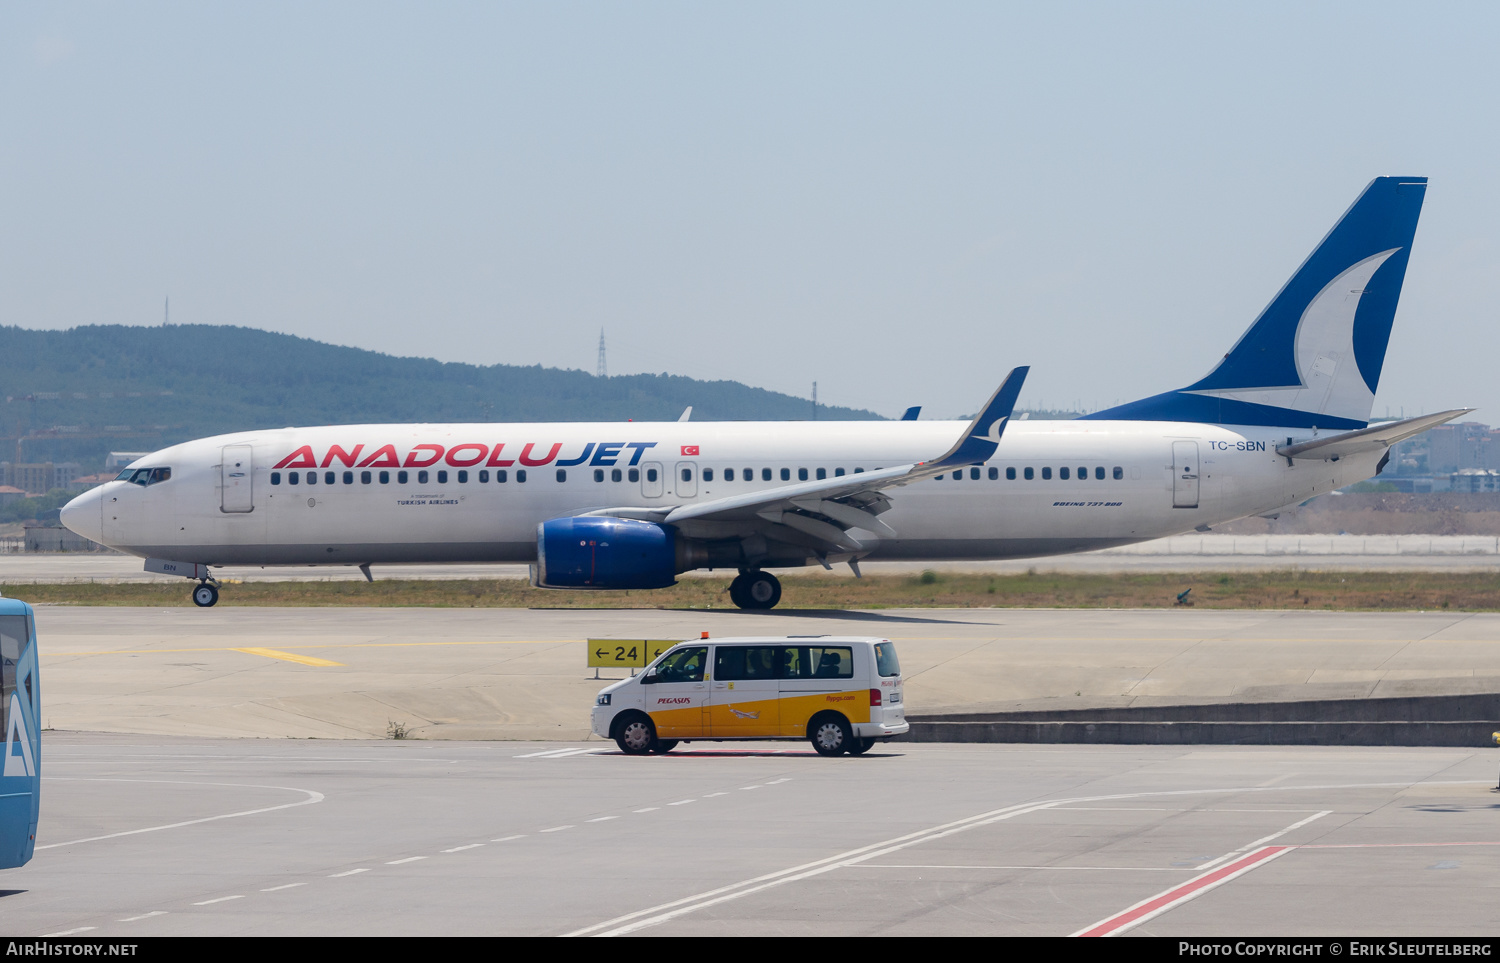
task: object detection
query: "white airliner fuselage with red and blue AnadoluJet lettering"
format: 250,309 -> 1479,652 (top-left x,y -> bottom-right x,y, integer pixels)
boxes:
63,420 -> 1379,566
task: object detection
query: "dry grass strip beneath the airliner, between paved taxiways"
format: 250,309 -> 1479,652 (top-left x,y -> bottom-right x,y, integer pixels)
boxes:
0,570 -> 1500,612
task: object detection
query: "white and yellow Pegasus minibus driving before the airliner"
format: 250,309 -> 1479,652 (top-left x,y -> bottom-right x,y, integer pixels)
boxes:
593,636 -> 909,756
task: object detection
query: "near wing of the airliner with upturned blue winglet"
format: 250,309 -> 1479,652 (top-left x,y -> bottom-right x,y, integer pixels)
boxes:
588,366 -> 1031,554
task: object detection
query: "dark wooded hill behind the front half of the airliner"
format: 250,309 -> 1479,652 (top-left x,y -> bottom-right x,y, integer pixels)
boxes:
0,324 -> 881,473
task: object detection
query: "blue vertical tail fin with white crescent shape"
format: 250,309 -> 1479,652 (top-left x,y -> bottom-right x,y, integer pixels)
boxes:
1085,177 -> 1427,428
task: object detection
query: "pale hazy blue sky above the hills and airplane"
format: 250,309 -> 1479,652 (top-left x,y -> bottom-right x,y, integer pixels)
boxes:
0,0 -> 1500,423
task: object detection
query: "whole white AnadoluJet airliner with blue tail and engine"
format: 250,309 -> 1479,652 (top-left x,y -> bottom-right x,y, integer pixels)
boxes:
63,177 -> 1470,609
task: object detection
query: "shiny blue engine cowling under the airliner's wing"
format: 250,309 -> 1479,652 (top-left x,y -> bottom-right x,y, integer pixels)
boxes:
531,516 -> 678,588
